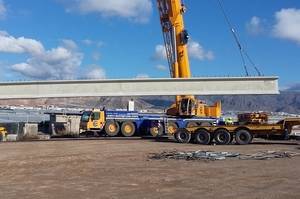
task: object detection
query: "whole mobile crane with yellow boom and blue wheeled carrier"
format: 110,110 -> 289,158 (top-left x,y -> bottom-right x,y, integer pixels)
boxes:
80,0 -> 221,137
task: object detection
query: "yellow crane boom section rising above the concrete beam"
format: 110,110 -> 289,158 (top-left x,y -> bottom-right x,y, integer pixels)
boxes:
157,0 -> 191,78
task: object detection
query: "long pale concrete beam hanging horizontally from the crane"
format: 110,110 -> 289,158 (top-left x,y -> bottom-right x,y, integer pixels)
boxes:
0,77 -> 279,99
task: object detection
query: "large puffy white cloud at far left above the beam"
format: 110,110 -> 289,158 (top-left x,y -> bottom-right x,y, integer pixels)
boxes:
0,31 -> 83,79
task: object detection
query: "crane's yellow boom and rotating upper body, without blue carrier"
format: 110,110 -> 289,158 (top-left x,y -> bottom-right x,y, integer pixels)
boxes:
157,0 -> 221,117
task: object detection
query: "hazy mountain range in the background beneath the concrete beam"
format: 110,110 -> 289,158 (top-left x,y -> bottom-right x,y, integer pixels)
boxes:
0,91 -> 300,114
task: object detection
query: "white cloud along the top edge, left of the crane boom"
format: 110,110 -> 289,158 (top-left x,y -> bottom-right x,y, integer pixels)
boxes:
64,0 -> 152,22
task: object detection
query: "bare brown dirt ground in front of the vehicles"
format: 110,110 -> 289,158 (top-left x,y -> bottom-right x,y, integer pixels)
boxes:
0,139 -> 300,199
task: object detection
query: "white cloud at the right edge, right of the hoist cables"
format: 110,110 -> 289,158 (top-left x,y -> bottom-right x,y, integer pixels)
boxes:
273,8 -> 300,44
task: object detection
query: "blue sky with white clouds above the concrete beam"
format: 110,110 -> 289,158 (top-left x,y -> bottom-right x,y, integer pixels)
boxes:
0,0 -> 300,88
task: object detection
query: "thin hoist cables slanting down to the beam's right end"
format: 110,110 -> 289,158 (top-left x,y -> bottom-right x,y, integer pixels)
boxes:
217,0 -> 262,76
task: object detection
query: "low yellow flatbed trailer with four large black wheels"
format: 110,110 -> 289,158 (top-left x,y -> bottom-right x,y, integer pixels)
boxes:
174,118 -> 300,145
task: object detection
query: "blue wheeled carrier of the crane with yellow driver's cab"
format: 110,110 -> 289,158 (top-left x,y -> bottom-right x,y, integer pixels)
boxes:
80,110 -> 218,137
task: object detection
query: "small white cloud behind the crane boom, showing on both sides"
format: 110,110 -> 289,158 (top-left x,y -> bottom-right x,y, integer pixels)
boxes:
152,41 -> 214,61
